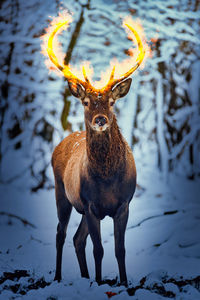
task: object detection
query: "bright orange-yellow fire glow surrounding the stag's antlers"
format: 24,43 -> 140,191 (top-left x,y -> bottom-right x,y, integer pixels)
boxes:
42,12 -> 150,89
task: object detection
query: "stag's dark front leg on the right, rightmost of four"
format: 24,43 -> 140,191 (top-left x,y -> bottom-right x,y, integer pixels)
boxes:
113,202 -> 129,286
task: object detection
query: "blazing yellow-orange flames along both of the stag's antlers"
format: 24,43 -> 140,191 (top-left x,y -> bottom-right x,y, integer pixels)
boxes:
42,12 -> 150,92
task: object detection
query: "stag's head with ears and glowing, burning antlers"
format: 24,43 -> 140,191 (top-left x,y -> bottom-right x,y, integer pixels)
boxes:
42,12 -> 148,132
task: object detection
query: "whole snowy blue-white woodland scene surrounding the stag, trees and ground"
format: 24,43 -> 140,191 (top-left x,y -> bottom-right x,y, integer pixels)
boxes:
0,0 -> 200,300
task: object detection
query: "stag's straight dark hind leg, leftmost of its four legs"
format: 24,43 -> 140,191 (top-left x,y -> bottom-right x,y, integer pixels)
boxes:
54,182 -> 72,281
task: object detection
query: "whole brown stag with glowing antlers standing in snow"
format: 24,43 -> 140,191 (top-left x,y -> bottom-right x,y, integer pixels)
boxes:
47,14 -> 145,286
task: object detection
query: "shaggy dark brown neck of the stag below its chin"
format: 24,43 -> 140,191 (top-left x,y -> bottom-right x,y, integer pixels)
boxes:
86,116 -> 126,179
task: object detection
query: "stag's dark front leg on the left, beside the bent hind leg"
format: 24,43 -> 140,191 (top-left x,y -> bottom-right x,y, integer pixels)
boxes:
85,207 -> 104,283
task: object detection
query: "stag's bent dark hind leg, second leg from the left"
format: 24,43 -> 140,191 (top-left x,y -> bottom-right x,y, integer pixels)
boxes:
73,215 -> 89,278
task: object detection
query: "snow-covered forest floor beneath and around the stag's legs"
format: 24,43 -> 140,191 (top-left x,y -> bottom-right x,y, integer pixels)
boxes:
0,165 -> 200,300
